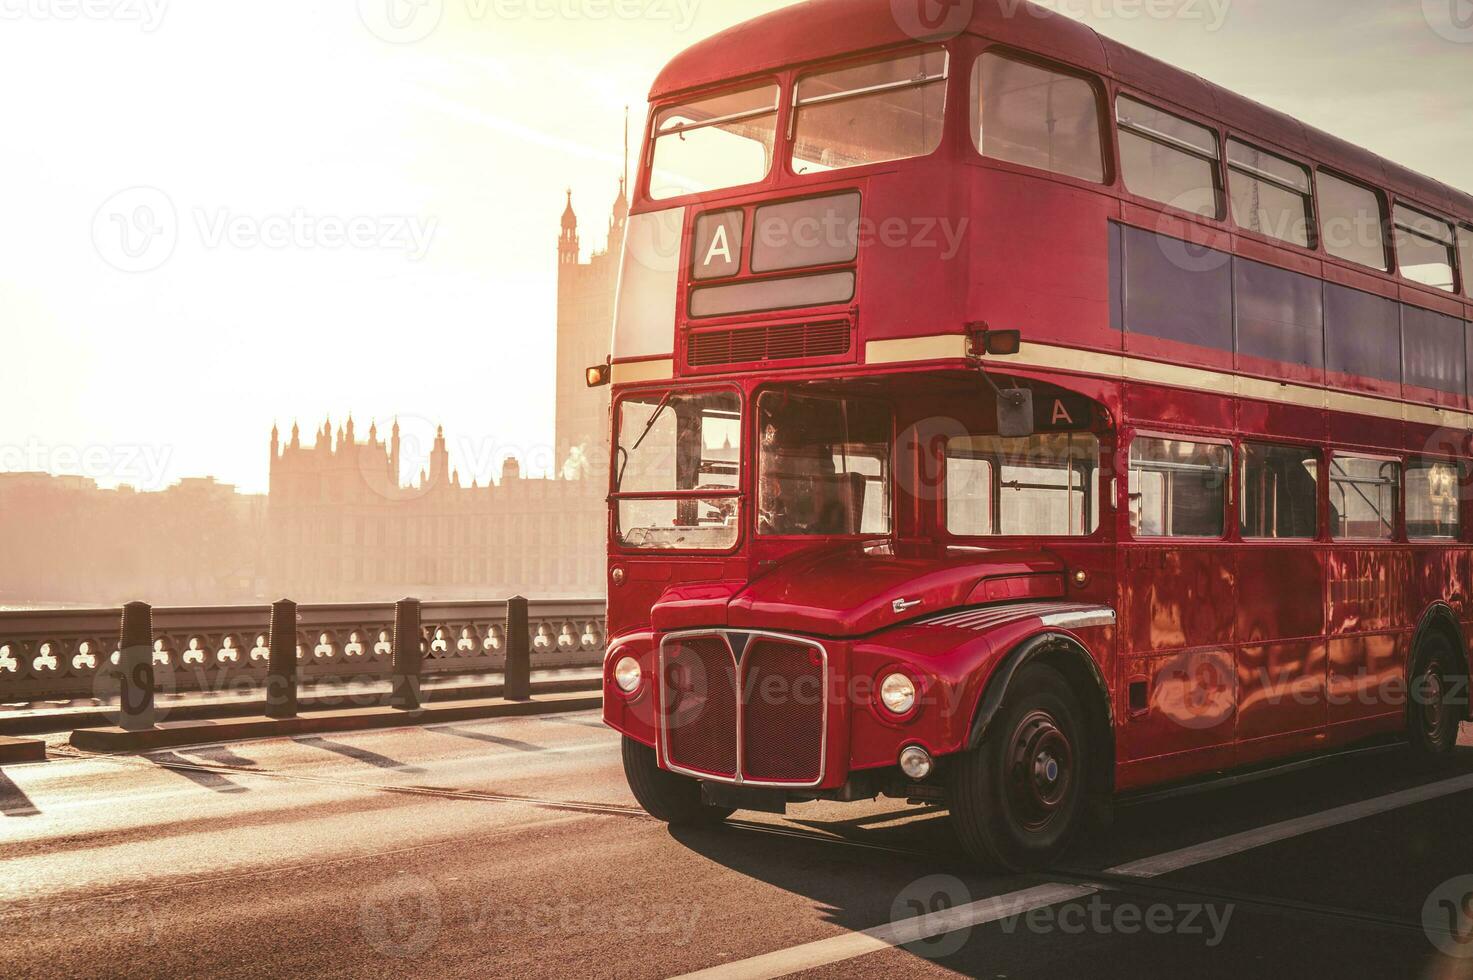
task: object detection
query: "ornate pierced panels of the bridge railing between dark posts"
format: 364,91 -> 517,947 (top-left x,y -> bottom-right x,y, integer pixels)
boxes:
0,598 -> 605,703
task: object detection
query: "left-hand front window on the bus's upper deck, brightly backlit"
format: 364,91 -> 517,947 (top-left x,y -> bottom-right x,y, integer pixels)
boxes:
650,84 -> 779,200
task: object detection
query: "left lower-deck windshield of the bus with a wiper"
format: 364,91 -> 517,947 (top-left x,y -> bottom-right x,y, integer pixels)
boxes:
614,391 -> 741,551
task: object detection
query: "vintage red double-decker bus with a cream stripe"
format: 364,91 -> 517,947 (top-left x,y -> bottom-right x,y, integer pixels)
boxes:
591,0 -> 1473,869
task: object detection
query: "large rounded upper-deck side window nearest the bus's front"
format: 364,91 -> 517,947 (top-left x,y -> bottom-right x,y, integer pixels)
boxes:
972,52 -> 1105,184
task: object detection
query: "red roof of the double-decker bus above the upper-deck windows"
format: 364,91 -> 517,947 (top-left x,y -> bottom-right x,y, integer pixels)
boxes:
650,0 -> 1473,221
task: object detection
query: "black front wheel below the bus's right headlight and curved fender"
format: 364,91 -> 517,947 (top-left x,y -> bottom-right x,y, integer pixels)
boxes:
950,663 -> 1089,872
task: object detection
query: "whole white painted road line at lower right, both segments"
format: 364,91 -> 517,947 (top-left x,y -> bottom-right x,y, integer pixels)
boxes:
679,775 -> 1473,980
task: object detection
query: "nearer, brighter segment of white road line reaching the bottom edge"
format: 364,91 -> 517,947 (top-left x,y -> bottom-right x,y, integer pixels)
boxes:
681,884 -> 1100,980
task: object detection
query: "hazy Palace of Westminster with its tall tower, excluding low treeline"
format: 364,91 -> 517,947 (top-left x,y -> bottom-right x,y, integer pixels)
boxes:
268,181 -> 629,603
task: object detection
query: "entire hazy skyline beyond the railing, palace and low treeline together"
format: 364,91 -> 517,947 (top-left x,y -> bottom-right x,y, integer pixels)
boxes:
0,178 -> 629,607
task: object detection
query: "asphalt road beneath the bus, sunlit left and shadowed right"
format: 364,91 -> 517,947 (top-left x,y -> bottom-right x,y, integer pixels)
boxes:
0,715 -> 1473,980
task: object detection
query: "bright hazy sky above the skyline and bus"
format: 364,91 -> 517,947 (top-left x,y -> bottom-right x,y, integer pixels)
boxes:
0,0 -> 1473,491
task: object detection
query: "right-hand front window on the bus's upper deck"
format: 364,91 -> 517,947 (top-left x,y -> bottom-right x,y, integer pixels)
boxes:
792,49 -> 947,174
